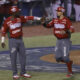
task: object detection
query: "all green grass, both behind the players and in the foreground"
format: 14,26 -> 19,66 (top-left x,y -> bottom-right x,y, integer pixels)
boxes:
0,33 -> 80,80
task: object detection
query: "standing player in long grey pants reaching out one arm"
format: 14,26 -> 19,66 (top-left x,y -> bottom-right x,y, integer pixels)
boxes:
1,6 -> 40,79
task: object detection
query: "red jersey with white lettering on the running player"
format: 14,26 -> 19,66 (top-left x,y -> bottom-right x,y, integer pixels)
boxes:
47,17 -> 74,39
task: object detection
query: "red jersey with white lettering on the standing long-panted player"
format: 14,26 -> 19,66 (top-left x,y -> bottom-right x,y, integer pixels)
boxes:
2,16 -> 34,38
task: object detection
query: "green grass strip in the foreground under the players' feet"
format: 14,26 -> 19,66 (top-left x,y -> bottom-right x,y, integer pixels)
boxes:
0,70 -> 80,80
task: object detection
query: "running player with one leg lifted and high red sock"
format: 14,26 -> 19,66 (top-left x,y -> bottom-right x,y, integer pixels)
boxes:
42,7 -> 74,77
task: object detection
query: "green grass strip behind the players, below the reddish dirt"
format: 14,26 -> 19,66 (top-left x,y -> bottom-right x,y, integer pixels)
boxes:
0,33 -> 80,51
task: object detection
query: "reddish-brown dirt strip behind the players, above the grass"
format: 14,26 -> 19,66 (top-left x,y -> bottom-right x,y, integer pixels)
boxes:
23,22 -> 80,37
